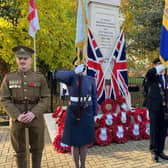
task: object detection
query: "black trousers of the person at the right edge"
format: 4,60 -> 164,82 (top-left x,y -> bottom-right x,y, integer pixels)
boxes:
149,111 -> 167,153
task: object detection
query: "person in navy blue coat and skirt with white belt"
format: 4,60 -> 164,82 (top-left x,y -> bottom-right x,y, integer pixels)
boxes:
53,59 -> 97,168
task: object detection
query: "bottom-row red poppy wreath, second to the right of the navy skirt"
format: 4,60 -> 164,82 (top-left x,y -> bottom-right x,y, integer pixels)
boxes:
113,125 -> 129,143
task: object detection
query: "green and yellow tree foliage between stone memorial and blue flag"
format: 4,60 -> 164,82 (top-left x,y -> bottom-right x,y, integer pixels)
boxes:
121,0 -> 164,75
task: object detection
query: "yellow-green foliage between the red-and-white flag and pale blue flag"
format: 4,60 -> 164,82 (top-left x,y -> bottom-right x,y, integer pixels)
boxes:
37,0 -> 76,69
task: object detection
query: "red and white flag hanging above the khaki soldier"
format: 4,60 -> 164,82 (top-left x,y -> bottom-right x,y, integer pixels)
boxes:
29,0 -> 40,37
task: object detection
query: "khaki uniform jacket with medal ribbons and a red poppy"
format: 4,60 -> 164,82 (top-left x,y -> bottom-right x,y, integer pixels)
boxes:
0,71 -> 49,121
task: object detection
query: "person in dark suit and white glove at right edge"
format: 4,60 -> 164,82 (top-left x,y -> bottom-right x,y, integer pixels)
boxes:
144,58 -> 168,162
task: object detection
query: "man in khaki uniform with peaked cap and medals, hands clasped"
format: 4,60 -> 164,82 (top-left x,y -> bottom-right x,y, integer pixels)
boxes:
0,46 -> 49,168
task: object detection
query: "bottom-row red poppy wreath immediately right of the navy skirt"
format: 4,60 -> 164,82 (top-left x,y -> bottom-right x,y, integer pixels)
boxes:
95,127 -> 113,146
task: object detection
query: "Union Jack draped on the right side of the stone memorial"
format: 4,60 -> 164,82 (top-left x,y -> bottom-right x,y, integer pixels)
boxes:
110,31 -> 128,100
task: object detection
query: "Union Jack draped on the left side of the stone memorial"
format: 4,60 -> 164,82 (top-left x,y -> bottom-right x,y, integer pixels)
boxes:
87,29 -> 105,104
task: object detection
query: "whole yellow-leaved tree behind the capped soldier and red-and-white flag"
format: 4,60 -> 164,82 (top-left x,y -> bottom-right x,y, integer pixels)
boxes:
0,0 -> 77,70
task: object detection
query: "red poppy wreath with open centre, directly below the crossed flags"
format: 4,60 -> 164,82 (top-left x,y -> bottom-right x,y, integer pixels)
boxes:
101,98 -> 117,113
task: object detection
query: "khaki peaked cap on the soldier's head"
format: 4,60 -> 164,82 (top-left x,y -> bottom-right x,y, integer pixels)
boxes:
12,45 -> 34,58
